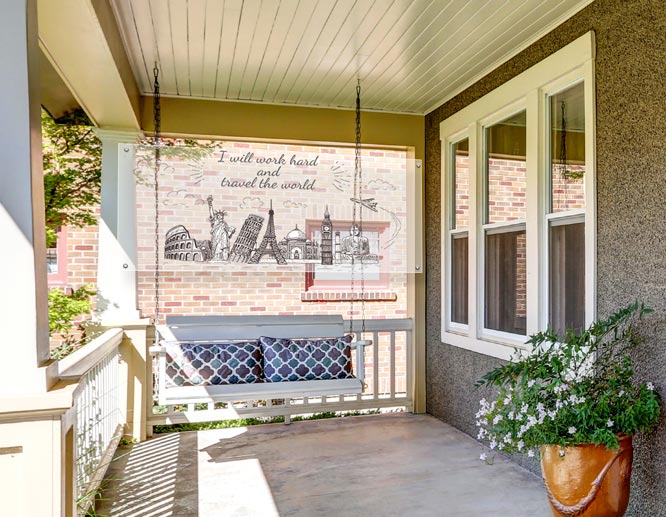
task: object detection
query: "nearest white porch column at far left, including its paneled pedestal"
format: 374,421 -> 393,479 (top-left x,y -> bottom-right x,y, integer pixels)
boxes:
0,0 -> 72,516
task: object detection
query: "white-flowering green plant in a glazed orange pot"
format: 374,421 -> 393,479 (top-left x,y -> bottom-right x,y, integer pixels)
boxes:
476,302 -> 660,516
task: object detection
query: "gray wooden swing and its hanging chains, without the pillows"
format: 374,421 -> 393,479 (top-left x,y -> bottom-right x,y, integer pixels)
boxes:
150,69 -> 372,423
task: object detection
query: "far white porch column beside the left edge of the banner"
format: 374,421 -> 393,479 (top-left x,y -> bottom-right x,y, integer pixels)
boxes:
96,129 -> 141,321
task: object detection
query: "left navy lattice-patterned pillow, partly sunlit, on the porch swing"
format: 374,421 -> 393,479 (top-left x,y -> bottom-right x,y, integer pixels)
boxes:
166,341 -> 263,387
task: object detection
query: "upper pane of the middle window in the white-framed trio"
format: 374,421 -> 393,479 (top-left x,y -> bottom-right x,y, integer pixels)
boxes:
485,111 -> 527,223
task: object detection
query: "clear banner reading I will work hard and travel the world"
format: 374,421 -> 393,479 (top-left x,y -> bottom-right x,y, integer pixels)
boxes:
136,142 -> 409,272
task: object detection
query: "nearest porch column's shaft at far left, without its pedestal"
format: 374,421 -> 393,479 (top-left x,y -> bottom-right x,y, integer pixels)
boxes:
0,0 -> 49,397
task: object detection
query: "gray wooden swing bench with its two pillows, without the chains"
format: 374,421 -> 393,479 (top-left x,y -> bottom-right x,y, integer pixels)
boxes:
150,316 -> 372,421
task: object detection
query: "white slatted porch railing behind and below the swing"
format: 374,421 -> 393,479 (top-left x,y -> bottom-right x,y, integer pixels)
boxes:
148,318 -> 414,434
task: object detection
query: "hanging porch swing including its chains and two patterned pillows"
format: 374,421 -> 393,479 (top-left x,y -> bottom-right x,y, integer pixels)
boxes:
150,67 -> 372,423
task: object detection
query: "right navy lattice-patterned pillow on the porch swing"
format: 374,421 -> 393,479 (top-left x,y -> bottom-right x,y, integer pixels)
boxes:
259,335 -> 354,382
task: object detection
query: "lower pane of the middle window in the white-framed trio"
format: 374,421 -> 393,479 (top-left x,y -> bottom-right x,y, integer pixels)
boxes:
485,230 -> 527,335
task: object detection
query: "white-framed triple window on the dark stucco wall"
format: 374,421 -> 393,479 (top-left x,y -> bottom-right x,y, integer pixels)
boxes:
440,33 -> 595,358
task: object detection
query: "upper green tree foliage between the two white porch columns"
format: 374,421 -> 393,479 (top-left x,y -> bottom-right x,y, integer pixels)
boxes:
42,111 -> 102,247
